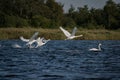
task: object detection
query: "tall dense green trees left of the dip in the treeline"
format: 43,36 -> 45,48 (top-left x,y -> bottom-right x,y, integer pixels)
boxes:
0,0 -> 63,28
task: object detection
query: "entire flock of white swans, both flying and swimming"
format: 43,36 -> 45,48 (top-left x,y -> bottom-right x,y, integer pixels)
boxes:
12,27 -> 102,51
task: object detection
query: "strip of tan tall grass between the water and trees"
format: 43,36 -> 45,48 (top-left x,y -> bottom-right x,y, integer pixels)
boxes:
0,28 -> 120,40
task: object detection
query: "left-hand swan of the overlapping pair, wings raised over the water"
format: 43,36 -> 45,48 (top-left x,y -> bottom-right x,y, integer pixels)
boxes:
20,32 -> 38,48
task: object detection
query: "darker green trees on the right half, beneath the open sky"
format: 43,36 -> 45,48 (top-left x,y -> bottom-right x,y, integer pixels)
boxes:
66,0 -> 120,29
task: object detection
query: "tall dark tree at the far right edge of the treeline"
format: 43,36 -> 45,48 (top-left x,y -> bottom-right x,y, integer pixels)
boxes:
104,0 -> 120,29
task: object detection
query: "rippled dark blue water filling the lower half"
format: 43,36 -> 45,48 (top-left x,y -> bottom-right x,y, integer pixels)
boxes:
0,40 -> 120,80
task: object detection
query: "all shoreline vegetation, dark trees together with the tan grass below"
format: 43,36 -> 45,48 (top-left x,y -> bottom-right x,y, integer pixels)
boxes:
0,0 -> 120,40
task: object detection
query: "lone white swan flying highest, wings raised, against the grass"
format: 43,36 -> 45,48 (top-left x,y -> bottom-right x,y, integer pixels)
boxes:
60,27 -> 83,40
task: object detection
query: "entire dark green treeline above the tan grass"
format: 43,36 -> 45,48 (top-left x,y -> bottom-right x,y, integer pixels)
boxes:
0,0 -> 120,29
